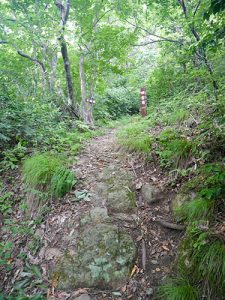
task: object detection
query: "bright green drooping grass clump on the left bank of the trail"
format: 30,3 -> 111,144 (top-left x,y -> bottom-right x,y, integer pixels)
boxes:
23,153 -> 76,197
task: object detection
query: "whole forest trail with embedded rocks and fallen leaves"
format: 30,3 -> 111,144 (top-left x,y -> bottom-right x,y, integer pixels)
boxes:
36,129 -> 180,300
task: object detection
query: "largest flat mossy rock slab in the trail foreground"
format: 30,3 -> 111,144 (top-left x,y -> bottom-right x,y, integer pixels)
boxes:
53,224 -> 136,291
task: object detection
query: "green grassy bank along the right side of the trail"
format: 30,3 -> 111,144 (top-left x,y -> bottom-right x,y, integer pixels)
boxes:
118,91 -> 225,300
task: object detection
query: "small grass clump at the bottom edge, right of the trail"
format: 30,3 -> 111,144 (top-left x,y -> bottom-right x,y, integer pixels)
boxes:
158,279 -> 199,300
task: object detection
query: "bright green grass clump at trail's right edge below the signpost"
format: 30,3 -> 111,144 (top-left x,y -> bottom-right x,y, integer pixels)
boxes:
118,123 -> 152,153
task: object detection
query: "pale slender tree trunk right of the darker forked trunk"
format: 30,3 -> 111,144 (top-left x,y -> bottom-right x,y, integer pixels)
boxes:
80,53 -> 94,125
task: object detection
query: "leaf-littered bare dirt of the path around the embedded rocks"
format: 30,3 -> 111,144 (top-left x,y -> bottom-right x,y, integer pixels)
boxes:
40,130 -> 180,300
